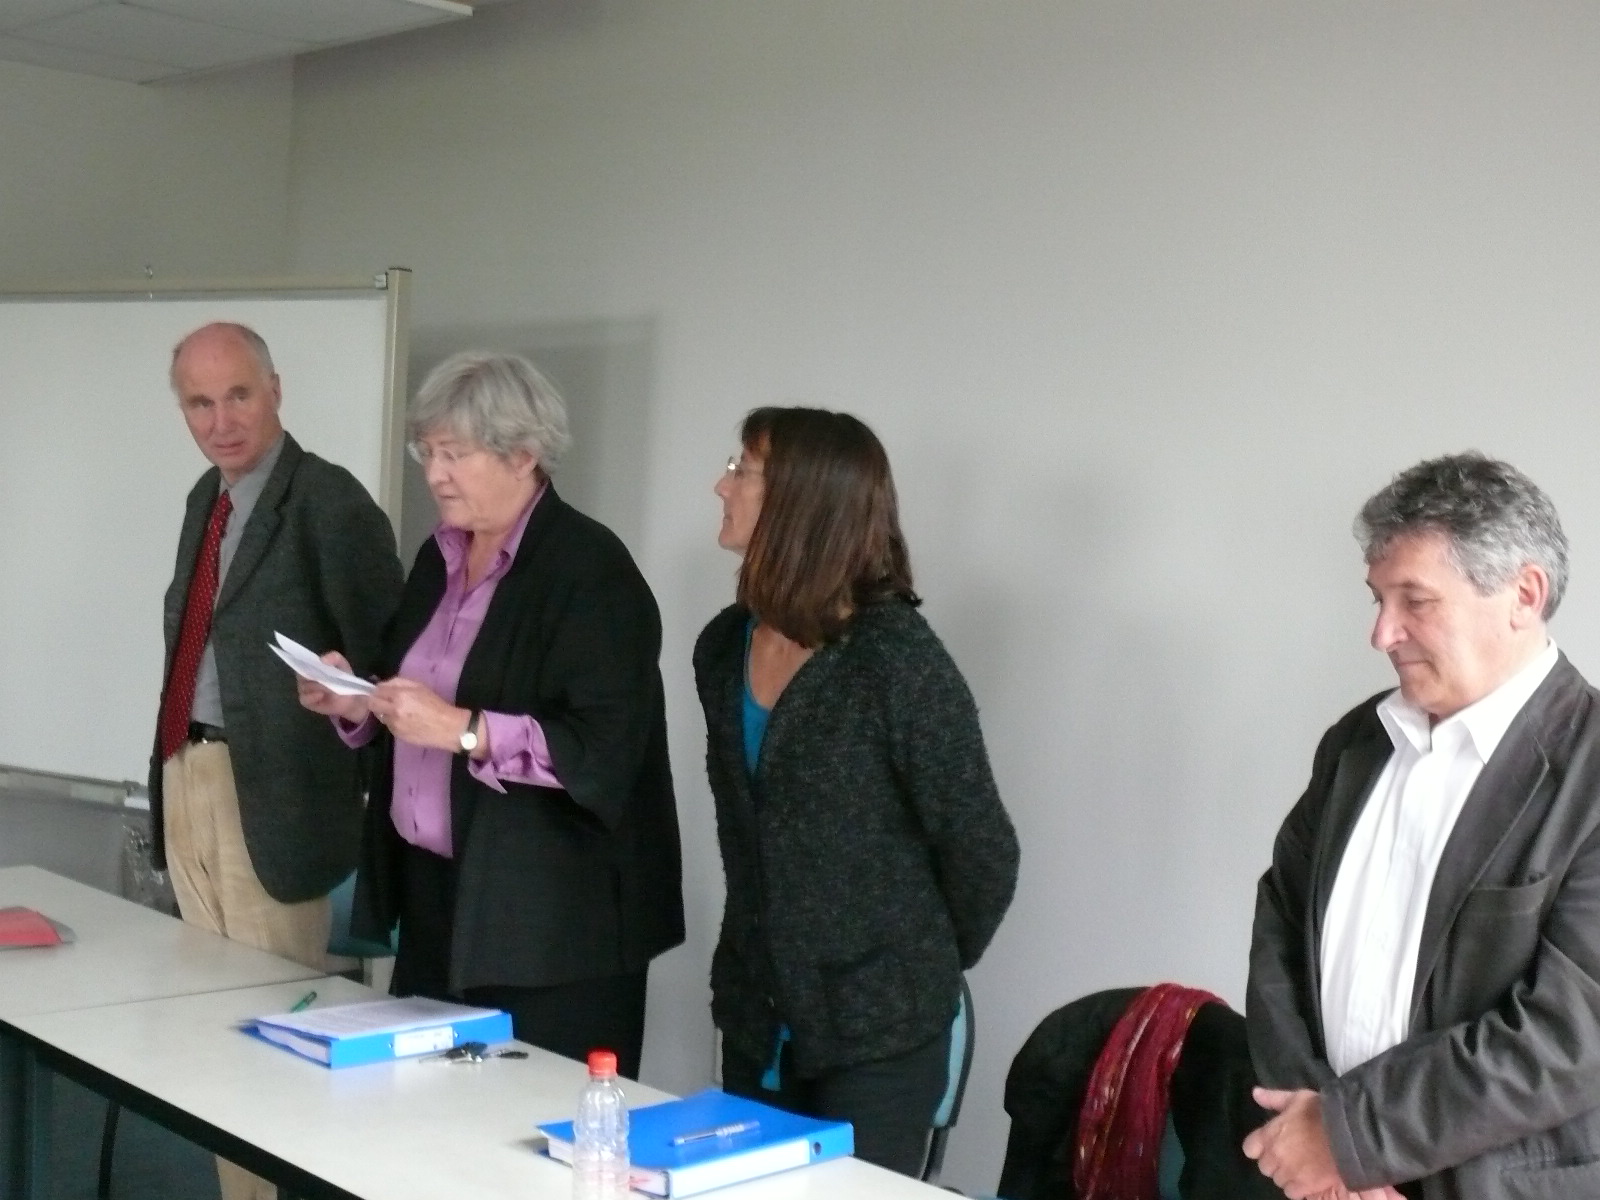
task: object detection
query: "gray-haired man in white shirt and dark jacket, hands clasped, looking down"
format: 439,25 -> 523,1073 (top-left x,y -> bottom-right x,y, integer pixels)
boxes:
1245,454 -> 1600,1200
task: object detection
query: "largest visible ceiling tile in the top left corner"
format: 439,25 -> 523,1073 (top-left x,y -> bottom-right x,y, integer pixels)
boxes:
27,5 -> 312,70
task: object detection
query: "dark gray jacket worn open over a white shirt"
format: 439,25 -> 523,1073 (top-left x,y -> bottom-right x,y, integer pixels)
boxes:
1246,654 -> 1600,1200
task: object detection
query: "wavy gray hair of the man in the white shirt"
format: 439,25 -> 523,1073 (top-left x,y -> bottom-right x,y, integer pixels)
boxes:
1355,450 -> 1566,621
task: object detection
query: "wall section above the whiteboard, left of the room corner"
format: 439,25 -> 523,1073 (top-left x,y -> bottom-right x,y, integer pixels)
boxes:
0,62 -> 293,281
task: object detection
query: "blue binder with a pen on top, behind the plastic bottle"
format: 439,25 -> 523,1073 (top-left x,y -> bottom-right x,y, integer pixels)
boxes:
539,1088 -> 856,1197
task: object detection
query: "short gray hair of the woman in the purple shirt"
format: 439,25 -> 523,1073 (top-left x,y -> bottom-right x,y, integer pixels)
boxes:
406,350 -> 571,467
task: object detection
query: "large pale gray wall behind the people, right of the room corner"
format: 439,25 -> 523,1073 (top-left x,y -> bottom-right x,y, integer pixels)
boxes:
291,0 -> 1600,1189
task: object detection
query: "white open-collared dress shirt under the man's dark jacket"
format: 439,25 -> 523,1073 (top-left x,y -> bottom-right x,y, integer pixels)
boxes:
1322,642 -> 1557,1075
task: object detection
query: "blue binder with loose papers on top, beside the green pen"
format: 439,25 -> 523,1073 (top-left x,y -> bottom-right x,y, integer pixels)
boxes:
242,997 -> 510,1067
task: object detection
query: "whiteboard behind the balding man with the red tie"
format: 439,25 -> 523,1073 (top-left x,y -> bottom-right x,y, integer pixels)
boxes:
0,270 -> 410,793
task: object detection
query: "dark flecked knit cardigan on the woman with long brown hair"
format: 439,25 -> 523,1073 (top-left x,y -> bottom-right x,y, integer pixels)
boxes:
694,600 -> 1018,1077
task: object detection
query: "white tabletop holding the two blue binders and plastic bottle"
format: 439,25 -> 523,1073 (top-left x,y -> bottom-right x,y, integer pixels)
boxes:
16,978 -> 947,1200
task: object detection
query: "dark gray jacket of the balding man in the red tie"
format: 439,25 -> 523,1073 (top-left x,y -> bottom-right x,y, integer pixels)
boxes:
150,434 -> 400,904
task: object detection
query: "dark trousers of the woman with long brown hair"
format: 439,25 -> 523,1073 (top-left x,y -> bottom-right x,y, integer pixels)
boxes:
722,1030 -> 950,1178
